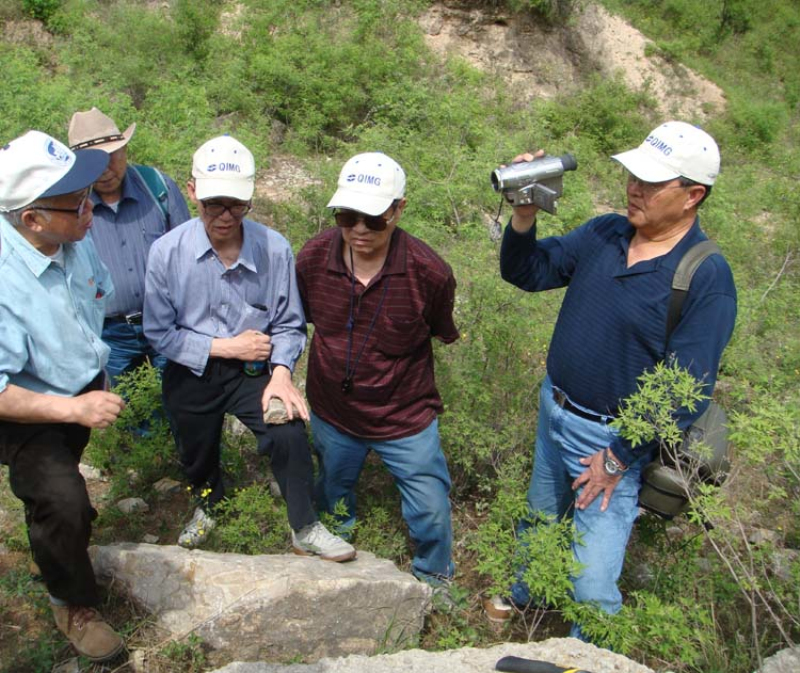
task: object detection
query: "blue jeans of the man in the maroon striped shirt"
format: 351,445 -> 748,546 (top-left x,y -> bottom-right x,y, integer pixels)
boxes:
311,413 -> 455,584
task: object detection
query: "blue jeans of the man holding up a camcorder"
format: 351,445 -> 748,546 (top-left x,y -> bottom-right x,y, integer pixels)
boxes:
511,377 -> 649,640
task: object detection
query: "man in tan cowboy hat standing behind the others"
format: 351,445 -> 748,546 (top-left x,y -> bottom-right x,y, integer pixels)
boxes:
69,107 -> 189,385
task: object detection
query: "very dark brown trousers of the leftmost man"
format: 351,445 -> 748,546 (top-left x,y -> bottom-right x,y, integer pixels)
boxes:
0,376 -> 102,606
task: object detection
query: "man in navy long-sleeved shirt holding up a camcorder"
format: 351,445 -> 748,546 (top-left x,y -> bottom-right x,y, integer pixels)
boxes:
494,121 -> 736,638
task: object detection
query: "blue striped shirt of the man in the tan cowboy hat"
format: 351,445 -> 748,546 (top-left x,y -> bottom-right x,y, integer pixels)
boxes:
89,167 -> 189,315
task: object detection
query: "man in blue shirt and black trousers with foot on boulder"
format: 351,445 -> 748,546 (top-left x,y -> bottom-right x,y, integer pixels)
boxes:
144,135 -> 356,562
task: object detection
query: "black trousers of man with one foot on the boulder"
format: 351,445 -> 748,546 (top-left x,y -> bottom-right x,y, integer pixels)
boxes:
163,358 -> 317,530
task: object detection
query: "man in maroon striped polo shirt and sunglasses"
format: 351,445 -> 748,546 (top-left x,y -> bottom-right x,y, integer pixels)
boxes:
297,152 -> 458,607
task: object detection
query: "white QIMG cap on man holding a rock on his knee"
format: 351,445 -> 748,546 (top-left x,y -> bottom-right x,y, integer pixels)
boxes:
192,134 -> 256,201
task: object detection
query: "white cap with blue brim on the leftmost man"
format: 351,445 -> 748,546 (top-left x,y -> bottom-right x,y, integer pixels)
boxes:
0,131 -> 108,213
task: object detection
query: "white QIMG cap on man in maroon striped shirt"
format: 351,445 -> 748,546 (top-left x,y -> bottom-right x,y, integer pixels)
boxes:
328,152 -> 406,215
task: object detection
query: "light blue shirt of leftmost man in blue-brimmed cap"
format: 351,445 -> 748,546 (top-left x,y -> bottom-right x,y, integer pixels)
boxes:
0,215 -> 113,397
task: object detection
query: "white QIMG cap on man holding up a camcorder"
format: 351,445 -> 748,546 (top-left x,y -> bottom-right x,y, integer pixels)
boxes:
611,121 -> 719,185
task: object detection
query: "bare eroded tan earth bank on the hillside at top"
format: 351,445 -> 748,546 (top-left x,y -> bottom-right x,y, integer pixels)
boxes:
420,2 -> 725,121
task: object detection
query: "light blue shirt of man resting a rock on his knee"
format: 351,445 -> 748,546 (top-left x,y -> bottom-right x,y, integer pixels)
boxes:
144,218 -> 306,376
